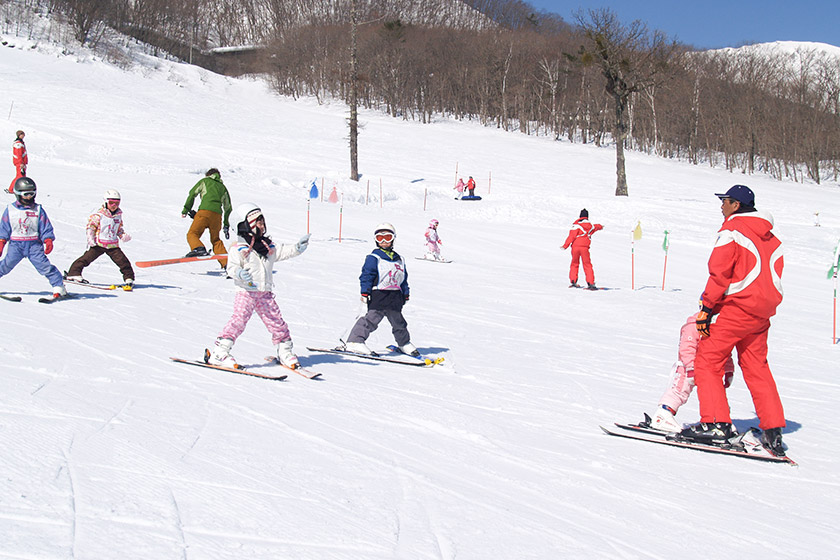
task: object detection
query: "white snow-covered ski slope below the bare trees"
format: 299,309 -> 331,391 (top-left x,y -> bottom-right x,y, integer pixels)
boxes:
0,35 -> 840,560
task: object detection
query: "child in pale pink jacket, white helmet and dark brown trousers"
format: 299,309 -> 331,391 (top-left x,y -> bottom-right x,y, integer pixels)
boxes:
65,189 -> 134,291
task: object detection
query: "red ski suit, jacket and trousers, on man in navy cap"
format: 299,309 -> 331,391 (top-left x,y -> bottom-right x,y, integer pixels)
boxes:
694,212 -> 785,430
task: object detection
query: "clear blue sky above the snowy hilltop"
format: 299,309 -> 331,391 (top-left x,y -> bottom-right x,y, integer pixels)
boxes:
526,0 -> 840,48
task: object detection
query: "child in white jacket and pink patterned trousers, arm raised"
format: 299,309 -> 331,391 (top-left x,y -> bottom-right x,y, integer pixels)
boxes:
204,203 -> 309,369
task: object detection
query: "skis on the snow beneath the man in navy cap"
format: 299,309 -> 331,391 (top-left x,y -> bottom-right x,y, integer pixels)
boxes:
601,414 -> 797,466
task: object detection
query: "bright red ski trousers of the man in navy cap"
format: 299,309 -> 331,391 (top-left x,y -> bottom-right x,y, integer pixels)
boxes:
694,305 -> 785,430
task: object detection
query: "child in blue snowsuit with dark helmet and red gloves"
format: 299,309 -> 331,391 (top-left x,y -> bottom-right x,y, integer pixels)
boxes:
0,177 -> 67,297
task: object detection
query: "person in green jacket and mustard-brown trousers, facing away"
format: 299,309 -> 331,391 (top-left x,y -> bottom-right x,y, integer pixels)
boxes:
181,167 -> 231,268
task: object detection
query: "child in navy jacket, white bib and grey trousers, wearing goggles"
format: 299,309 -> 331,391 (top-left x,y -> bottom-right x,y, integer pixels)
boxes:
345,223 -> 420,357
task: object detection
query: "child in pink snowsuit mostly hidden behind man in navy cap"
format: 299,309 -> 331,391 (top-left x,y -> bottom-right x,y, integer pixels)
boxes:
650,313 -> 735,432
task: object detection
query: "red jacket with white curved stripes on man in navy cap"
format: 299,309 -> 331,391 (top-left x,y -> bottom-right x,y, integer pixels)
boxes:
703,212 -> 784,319
